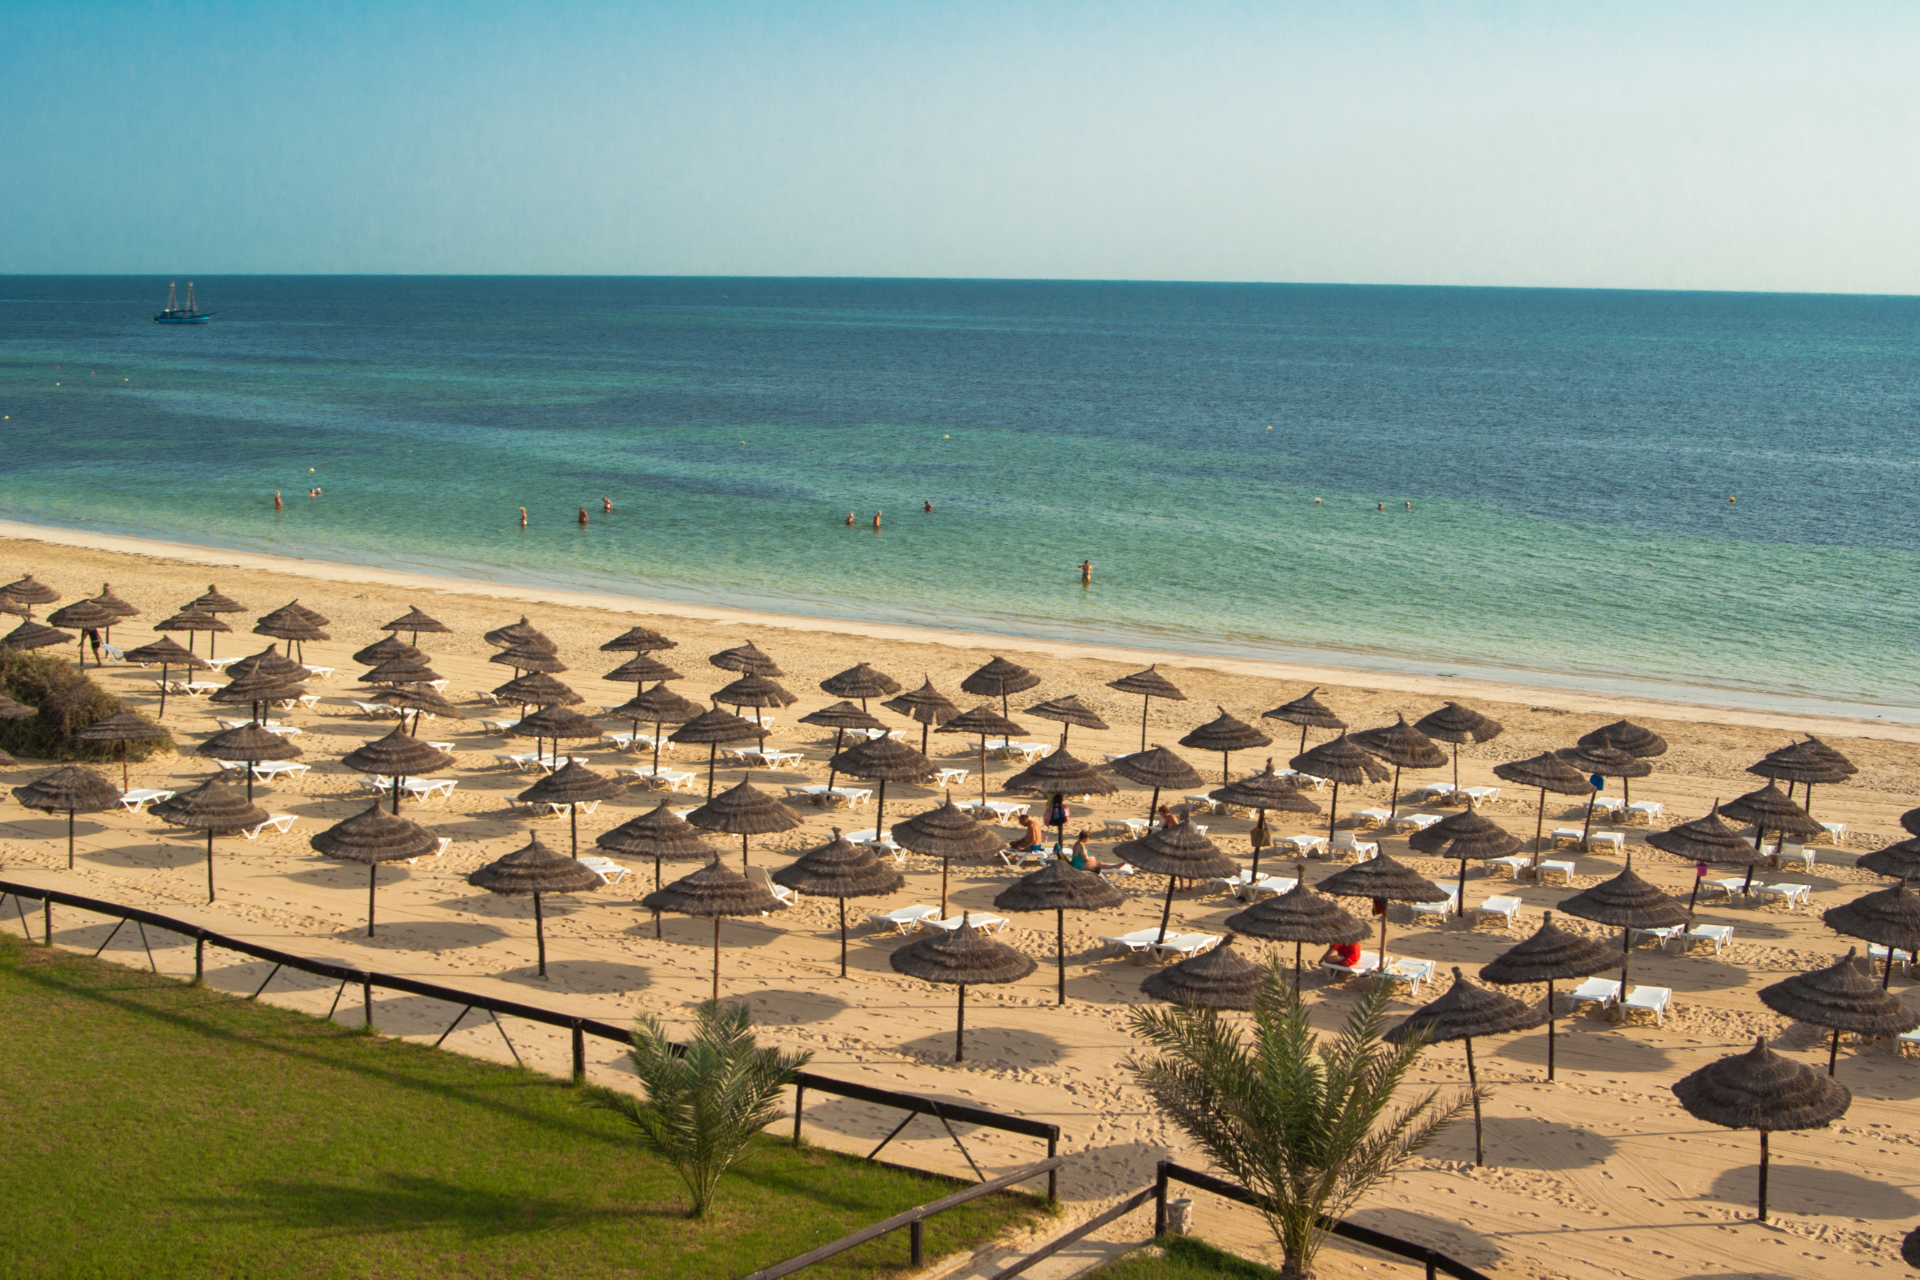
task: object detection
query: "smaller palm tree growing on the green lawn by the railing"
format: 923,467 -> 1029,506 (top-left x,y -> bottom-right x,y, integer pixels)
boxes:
586,1000 -> 812,1219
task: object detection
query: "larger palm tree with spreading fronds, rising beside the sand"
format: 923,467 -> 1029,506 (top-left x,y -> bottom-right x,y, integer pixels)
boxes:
1127,963 -> 1484,1280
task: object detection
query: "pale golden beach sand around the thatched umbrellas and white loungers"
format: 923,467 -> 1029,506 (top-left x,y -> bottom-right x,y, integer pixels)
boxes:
0,530 -> 1920,1276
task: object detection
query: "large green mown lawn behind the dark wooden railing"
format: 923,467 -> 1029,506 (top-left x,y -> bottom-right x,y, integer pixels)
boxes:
0,935 -> 1044,1280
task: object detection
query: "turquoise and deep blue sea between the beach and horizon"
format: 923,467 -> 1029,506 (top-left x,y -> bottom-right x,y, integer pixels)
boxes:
0,276 -> 1920,720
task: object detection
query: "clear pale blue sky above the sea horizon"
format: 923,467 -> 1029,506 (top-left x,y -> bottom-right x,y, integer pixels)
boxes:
0,0 -> 1920,294
